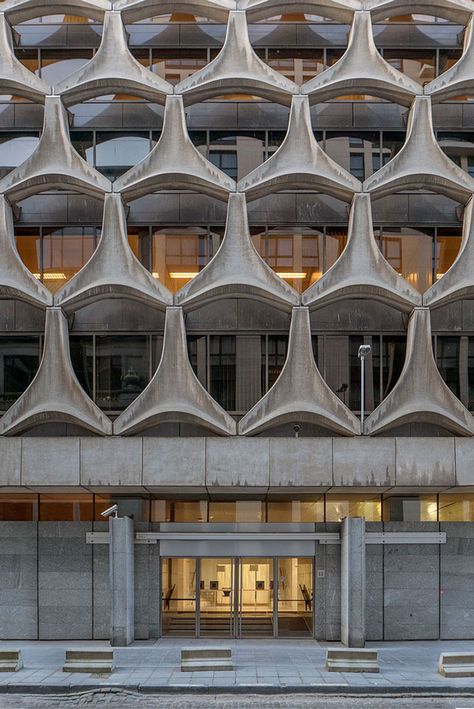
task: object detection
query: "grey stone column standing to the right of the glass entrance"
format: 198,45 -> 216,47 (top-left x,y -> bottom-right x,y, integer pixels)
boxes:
341,517 -> 365,647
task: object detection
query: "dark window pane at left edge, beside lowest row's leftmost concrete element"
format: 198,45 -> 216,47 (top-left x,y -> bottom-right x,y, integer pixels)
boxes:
0,335 -> 40,411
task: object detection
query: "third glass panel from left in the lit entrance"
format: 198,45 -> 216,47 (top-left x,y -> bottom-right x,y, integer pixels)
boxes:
236,557 -> 274,637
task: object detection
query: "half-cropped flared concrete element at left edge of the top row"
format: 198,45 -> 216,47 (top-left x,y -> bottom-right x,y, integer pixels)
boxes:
0,12 -> 51,103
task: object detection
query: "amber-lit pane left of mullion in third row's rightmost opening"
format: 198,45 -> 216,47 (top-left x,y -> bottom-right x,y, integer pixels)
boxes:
381,227 -> 433,293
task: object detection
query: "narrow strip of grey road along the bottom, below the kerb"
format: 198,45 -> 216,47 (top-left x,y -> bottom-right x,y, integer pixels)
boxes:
0,691 -> 474,709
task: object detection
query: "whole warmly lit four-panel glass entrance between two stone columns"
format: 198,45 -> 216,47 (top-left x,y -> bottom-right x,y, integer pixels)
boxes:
161,557 -> 314,637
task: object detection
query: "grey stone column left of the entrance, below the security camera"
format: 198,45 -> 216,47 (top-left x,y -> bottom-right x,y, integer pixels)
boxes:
109,517 -> 135,647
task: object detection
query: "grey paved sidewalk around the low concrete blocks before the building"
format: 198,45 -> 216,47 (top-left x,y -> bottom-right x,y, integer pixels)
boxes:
0,638 -> 474,692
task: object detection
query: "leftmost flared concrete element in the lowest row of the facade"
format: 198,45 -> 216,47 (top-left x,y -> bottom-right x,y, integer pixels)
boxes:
0,308 -> 112,435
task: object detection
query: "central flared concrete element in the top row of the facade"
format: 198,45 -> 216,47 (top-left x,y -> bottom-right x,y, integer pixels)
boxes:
175,11 -> 298,106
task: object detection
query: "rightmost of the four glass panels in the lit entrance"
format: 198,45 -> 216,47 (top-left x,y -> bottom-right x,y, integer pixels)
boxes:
277,557 -> 314,637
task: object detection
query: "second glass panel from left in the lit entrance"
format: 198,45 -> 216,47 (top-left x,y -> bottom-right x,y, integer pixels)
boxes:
199,558 -> 234,637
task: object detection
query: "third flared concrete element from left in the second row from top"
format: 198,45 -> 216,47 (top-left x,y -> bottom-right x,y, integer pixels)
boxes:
238,96 -> 362,202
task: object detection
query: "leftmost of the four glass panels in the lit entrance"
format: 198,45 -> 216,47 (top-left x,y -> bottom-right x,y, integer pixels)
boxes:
161,558 -> 196,637
